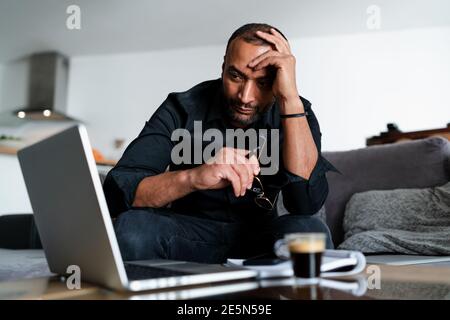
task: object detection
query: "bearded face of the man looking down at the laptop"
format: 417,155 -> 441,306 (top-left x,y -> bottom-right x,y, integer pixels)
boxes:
222,38 -> 274,128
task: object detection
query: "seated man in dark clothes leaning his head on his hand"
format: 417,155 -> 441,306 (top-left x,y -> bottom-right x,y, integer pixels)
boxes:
104,24 -> 334,263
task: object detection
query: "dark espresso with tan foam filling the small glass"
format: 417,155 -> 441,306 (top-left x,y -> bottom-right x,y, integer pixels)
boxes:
289,238 -> 325,278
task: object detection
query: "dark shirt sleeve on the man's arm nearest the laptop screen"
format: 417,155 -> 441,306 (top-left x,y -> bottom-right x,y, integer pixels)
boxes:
103,96 -> 180,217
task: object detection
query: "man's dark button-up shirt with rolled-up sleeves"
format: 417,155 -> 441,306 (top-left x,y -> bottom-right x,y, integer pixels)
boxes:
104,79 -> 335,221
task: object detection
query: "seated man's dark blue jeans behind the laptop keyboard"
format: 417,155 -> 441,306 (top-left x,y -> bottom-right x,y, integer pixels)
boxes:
114,208 -> 333,263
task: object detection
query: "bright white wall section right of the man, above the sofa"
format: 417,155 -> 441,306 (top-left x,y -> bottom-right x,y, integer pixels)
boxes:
293,27 -> 450,150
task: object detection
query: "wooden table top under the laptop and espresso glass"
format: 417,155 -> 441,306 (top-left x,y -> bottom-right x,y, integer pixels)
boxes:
0,265 -> 450,300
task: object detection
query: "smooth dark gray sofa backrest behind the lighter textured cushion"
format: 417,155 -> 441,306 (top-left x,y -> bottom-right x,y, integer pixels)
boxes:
323,137 -> 450,246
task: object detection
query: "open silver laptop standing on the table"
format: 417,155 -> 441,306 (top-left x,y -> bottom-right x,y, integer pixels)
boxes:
18,124 -> 256,291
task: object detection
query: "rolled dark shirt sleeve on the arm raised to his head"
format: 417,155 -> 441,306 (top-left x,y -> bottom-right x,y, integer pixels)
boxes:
280,98 -> 338,215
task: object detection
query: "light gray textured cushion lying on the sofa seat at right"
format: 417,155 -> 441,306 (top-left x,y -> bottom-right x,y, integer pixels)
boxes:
339,182 -> 450,255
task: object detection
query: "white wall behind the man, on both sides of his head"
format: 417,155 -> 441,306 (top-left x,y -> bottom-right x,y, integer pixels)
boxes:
68,27 -> 450,156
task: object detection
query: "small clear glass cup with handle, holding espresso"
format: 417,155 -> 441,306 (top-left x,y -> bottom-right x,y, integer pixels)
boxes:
276,233 -> 326,280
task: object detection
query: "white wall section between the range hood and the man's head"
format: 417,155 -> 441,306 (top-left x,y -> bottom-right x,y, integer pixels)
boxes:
68,47 -> 223,157
